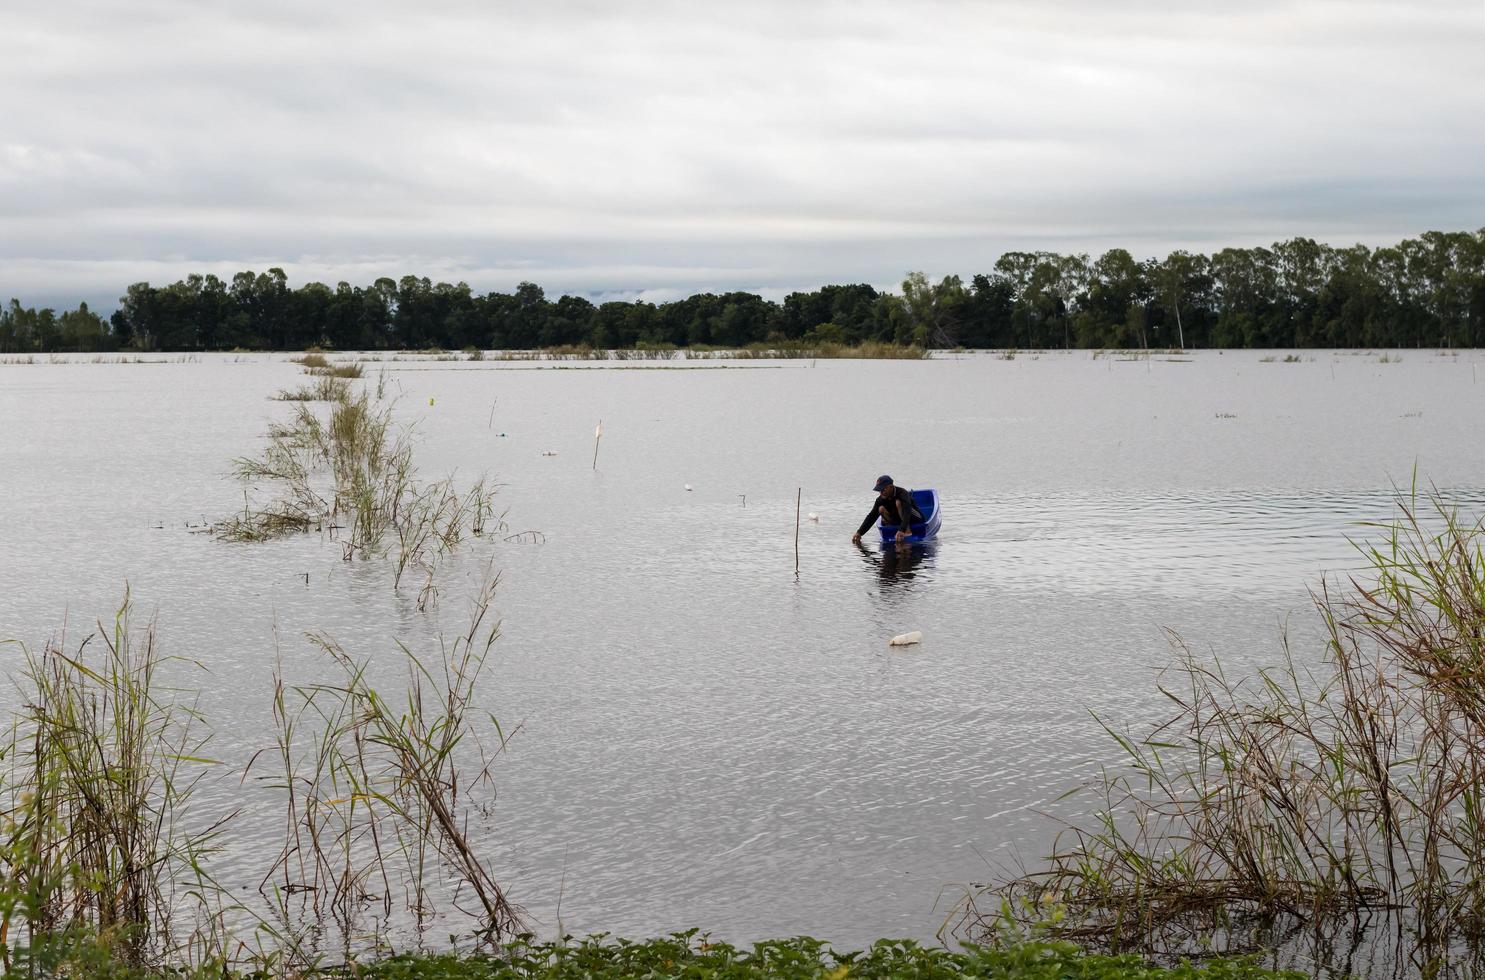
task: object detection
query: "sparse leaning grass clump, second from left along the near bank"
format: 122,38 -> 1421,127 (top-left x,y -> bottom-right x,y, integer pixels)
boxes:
260,578 -> 523,943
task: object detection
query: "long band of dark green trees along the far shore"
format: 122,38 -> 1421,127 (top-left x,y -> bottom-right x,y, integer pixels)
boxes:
0,229 -> 1485,353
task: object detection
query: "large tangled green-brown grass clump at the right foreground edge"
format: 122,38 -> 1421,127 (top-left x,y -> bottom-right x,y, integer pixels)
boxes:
965,491 -> 1485,961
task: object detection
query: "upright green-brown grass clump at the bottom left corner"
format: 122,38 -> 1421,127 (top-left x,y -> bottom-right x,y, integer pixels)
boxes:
0,597 -> 223,976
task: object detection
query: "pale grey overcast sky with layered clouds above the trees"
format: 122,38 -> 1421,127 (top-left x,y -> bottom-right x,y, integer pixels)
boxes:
0,0 -> 1485,307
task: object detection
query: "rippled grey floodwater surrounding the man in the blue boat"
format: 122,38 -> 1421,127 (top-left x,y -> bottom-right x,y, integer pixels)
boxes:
0,350 -> 1485,944
